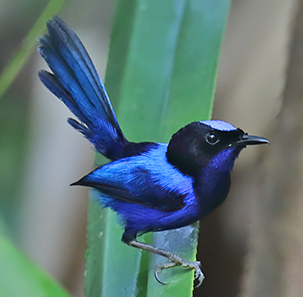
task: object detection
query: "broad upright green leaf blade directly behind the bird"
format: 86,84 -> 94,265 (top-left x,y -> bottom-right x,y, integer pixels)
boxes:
86,0 -> 230,297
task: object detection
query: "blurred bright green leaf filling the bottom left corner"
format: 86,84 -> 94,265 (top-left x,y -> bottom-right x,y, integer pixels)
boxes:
0,222 -> 70,297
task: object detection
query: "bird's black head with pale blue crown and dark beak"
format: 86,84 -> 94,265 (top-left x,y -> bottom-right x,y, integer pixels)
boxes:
166,120 -> 269,176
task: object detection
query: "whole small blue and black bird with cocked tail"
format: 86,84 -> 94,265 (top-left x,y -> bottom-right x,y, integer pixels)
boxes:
38,16 -> 269,284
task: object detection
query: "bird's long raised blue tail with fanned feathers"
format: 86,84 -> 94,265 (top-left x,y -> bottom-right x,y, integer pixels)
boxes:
38,16 -> 128,160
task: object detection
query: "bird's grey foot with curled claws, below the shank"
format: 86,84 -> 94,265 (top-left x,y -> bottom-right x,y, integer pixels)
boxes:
154,258 -> 204,288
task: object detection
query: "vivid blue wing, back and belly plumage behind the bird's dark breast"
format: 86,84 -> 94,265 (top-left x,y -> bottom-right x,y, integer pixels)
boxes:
76,143 -> 198,240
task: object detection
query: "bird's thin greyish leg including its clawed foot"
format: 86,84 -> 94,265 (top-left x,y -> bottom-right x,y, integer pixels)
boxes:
126,239 -> 204,287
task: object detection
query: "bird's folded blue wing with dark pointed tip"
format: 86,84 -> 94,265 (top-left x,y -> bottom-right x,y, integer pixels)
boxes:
74,151 -> 191,212
